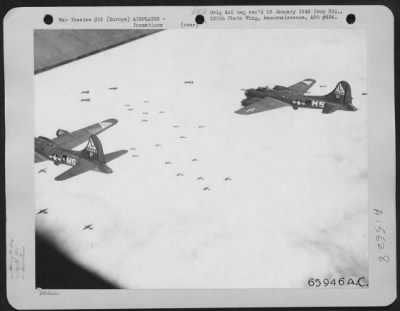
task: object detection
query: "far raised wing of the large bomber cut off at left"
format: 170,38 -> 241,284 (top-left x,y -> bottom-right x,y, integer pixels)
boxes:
53,119 -> 118,149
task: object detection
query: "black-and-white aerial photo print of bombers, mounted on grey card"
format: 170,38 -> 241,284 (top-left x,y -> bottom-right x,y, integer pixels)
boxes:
32,28 -> 369,290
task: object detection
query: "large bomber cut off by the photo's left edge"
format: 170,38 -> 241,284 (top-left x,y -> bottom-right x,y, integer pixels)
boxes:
35,119 -> 128,180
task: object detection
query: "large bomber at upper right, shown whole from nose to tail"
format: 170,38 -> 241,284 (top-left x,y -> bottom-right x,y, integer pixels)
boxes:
235,79 -> 357,115
